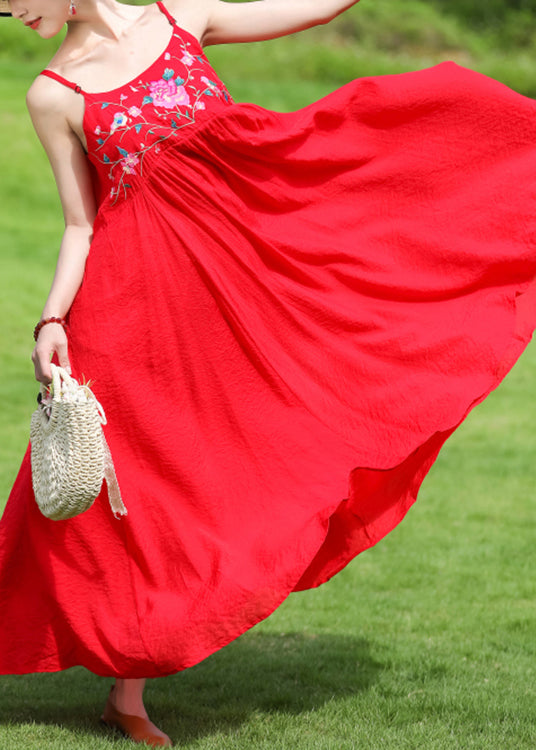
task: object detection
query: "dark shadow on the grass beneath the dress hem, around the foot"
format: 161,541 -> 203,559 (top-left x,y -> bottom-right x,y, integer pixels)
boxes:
0,632 -> 382,745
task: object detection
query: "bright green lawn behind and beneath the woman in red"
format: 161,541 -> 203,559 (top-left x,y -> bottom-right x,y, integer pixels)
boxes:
0,7 -> 536,750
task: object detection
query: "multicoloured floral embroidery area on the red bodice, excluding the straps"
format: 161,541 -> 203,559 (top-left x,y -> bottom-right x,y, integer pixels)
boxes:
88,30 -> 232,202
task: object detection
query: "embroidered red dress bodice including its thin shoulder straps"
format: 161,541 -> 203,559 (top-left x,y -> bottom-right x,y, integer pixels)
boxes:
43,2 -> 233,202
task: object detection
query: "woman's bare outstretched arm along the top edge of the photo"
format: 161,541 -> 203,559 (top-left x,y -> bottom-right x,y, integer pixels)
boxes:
197,0 -> 358,45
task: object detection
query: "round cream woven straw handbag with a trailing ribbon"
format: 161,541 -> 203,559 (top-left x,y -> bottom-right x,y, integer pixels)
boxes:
30,365 -> 127,521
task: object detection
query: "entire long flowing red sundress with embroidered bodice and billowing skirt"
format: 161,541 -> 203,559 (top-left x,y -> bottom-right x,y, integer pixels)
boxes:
0,1 -> 536,677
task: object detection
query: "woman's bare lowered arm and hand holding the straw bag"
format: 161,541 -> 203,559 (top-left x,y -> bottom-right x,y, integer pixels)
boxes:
27,77 -> 96,384
